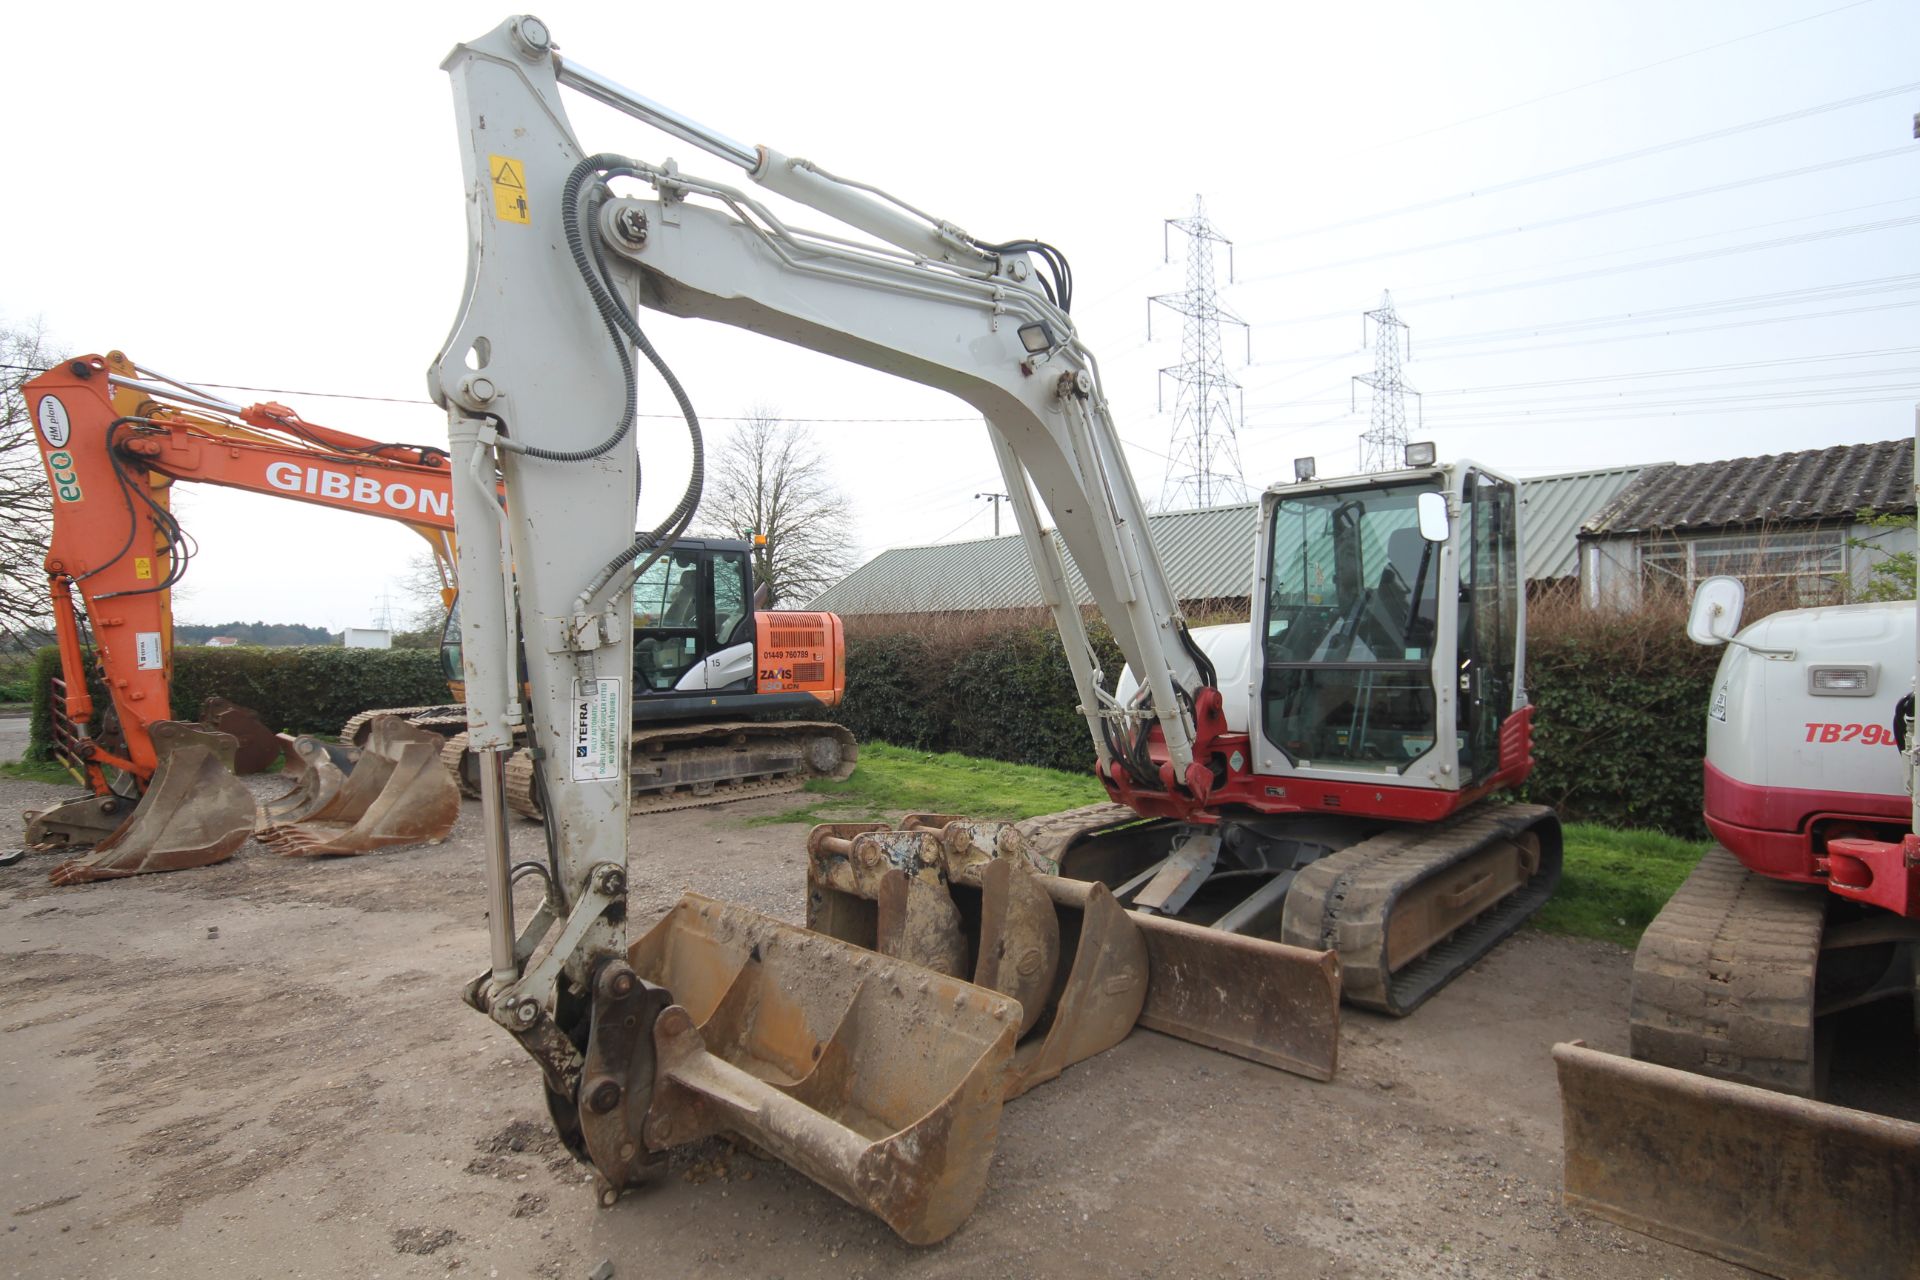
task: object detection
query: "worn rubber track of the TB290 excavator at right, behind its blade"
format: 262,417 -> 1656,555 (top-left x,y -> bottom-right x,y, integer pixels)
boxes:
1628,848 -> 1826,1098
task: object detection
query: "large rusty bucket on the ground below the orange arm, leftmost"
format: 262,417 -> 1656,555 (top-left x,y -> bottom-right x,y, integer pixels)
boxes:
48,720 -> 253,885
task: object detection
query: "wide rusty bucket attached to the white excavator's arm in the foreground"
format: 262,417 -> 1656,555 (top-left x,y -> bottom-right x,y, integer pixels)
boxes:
625,894 -> 1020,1244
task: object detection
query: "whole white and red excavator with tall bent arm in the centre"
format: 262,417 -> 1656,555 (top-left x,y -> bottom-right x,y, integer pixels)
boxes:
428,15 -> 1559,1242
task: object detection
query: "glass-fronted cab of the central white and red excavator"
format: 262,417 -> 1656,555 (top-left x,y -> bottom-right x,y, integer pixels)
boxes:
1250,464 -> 1521,791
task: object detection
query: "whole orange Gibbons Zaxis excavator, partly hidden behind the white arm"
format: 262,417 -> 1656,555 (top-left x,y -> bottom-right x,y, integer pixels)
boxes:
27,351 -> 858,883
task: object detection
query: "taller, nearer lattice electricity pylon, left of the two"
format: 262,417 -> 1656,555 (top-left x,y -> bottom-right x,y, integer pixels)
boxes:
1146,196 -> 1254,509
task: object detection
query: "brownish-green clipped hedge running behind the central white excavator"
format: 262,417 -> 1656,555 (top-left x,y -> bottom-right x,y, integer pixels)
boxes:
835,608 -> 1720,837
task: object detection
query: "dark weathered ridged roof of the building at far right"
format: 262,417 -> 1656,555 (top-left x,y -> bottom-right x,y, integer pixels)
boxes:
1580,439 -> 1914,537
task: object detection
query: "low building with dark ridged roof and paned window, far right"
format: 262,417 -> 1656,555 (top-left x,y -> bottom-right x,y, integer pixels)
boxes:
1578,439 -> 1914,608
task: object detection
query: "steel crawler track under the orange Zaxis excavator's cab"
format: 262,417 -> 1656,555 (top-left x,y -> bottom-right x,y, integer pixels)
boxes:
499,720 -> 858,821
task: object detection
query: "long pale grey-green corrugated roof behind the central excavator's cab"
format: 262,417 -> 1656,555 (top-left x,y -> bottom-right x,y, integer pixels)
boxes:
808,466 -> 1642,616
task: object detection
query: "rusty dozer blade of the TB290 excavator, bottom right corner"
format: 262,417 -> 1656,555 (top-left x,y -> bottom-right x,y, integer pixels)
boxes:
1553,1042 -> 1920,1280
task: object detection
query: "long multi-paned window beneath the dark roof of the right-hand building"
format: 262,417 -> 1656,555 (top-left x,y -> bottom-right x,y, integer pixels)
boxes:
1640,530 -> 1847,608
